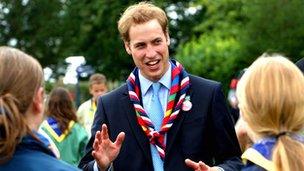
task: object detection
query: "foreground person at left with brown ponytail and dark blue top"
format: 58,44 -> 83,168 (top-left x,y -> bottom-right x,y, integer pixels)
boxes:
0,47 -> 78,171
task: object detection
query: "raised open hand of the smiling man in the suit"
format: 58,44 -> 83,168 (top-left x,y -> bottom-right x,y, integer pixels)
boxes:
92,124 -> 125,171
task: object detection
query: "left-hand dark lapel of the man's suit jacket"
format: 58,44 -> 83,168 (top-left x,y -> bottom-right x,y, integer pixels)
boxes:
121,89 -> 152,162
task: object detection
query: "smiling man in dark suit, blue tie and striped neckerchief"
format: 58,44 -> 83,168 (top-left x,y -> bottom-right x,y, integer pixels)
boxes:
79,2 -> 242,171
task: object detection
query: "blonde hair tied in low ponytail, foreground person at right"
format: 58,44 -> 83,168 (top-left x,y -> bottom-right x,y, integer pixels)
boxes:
237,55 -> 304,171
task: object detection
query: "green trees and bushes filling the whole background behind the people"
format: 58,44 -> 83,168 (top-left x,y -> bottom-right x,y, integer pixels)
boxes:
0,0 -> 304,92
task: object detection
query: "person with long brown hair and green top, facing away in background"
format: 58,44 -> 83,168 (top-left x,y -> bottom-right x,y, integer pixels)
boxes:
42,87 -> 88,166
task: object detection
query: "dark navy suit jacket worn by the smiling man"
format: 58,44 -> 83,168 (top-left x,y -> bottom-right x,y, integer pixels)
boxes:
79,75 -> 242,171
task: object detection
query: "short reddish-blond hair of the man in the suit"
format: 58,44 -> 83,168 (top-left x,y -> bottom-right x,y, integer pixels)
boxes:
118,2 -> 169,42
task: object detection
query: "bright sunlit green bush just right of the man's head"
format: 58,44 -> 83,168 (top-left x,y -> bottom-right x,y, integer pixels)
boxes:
177,31 -> 241,93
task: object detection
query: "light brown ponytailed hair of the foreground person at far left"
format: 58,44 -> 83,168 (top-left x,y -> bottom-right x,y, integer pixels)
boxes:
0,46 -> 43,163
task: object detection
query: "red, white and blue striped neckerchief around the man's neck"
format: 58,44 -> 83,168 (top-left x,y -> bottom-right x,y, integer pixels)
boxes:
127,60 -> 190,160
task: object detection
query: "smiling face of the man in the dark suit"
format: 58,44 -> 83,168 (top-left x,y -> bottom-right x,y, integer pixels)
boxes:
125,19 -> 170,81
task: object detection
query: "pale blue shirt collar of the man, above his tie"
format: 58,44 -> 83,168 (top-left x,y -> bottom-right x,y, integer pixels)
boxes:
138,62 -> 172,96
